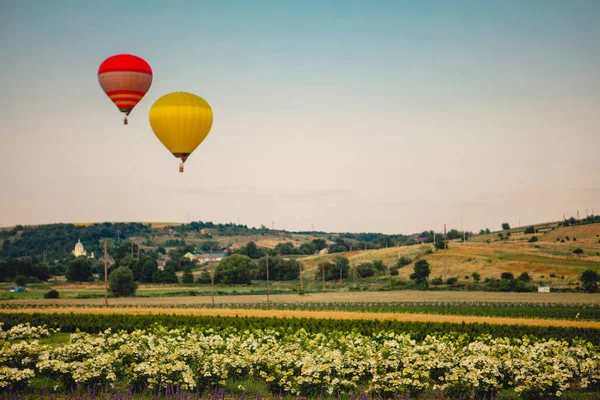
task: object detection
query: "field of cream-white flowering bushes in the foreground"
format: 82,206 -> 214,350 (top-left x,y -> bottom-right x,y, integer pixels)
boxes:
0,325 -> 600,398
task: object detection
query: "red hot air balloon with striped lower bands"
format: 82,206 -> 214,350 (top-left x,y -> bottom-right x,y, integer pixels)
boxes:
98,54 -> 152,125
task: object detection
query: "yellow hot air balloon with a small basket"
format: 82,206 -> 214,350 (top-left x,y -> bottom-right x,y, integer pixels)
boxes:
150,92 -> 213,172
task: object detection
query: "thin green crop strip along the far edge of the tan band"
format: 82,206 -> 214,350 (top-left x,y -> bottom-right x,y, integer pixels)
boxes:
0,302 -> 600,321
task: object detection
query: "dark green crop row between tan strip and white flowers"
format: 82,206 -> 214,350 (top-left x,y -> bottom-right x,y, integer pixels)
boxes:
0,313 -> 600,345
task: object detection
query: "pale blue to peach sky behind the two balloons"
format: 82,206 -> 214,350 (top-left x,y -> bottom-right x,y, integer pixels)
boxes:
0,0 -> 600,234
